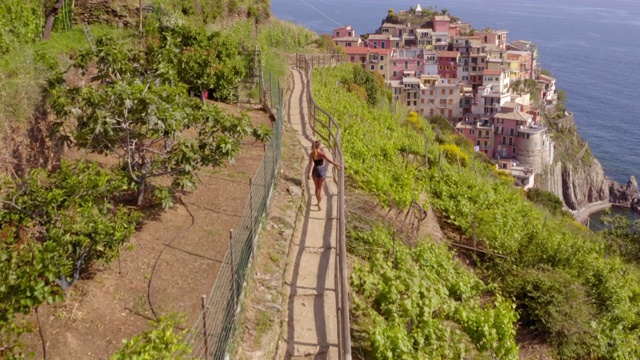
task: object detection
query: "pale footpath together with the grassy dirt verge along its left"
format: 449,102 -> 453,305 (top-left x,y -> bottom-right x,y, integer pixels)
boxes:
232,65 -> 338,360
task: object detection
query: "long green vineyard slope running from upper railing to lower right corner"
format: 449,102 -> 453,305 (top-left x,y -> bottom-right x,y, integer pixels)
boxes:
313,65 -> 640,359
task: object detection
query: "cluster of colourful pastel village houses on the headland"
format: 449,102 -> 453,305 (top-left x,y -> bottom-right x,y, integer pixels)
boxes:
332,4 -> 557,189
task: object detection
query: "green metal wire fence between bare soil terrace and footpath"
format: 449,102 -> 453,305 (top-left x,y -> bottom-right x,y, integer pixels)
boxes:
186,72 -> 284,360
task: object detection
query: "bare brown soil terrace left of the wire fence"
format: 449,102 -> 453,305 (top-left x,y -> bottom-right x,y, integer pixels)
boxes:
24,104 -> 271,360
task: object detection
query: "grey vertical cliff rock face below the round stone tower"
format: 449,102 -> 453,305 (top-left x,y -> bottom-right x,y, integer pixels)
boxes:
546,158 -> 611,210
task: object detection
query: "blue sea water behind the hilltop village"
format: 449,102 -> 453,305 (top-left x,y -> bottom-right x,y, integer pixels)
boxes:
271,0 -> 640,183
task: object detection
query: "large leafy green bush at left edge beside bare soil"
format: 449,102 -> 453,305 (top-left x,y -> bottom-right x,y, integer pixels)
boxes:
0,162 -> 139,355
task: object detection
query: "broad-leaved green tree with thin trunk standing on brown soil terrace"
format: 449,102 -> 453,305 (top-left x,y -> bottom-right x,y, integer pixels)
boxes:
50,39 -> 252,207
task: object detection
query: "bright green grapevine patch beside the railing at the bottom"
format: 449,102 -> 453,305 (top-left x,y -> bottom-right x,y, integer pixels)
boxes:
348,227 -> 518,359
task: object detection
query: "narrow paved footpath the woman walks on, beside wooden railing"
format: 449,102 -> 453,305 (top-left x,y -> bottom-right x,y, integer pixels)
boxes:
277,69 -> 338,360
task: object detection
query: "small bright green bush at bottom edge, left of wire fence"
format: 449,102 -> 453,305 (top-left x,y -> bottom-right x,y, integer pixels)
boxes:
111,315 -> 189,360
